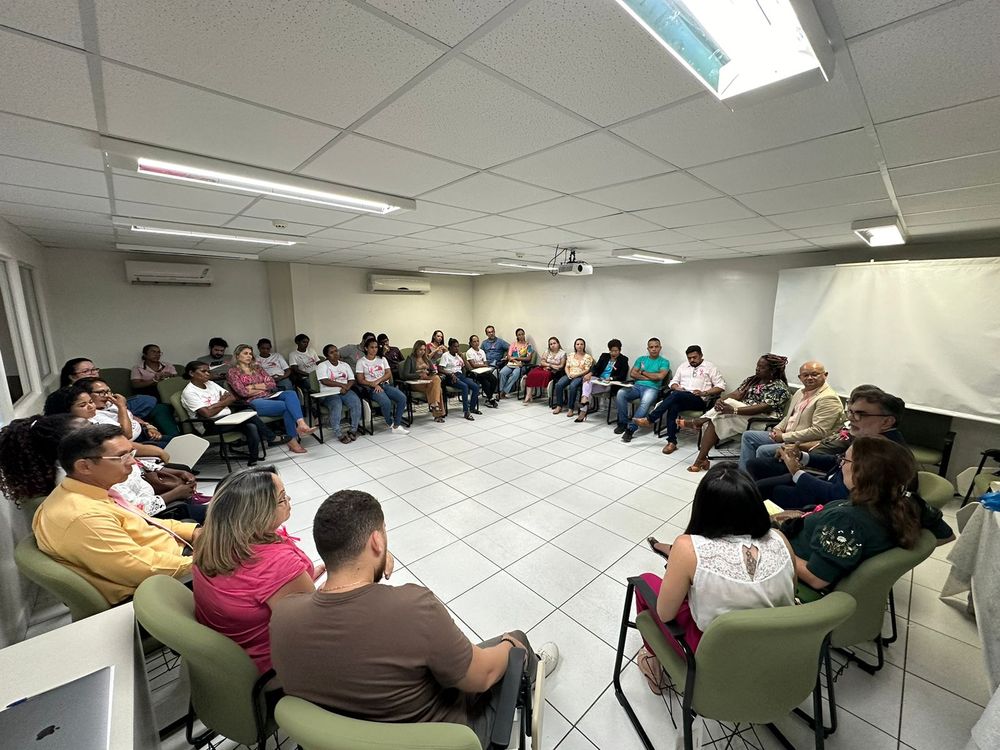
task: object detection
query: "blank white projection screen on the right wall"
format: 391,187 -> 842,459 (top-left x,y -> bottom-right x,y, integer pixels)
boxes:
771,258 -> 1000,424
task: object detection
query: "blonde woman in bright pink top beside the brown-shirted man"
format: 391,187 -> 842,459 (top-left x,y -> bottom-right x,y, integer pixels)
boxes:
191,466 -> 323,674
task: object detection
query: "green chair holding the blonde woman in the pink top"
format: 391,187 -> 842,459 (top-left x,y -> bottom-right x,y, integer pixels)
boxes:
133,576 -> 277,750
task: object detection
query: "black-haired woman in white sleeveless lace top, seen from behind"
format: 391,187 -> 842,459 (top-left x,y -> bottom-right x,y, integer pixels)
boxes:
636,462 -> 795,695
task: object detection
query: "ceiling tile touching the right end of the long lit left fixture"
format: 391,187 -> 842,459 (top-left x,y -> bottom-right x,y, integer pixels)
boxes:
301,134 -> 475,196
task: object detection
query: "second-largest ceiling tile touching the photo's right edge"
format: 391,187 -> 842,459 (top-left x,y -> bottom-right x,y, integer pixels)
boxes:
875,97 -> 1000,167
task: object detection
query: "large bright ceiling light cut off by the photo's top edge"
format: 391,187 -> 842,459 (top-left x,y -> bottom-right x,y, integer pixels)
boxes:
616,0 -> 833,101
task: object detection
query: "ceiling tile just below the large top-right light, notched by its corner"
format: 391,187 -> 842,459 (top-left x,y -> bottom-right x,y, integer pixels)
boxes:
614,75 -> 861,167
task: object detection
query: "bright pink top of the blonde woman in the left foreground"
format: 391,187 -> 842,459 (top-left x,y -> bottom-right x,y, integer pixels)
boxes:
191,539 -> 313,674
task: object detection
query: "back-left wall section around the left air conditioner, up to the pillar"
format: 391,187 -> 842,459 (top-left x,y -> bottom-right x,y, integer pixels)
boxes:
45,250 -> 272,367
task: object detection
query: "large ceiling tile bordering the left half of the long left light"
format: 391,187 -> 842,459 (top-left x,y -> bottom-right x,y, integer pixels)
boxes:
103,64 -> 340,171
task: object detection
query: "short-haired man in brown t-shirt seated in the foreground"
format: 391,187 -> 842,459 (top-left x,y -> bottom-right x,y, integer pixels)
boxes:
271,490 -> 559,747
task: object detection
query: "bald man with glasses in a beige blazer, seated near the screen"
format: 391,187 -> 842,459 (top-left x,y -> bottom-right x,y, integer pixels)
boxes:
740,362 -> 844,471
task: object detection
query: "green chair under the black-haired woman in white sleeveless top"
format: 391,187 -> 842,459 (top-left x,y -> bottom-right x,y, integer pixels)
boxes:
613,578 -> 855,750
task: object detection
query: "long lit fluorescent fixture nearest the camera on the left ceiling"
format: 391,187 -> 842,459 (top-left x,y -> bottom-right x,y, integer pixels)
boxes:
101,138 -> 417,214
